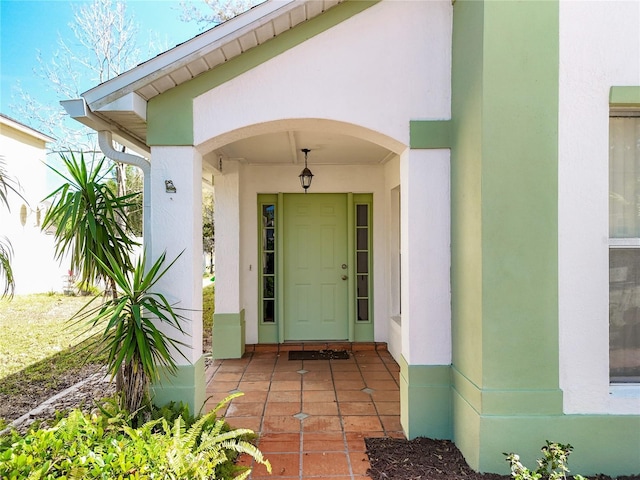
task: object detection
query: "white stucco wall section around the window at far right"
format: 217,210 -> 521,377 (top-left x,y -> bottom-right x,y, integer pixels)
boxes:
558,0 -> 640,414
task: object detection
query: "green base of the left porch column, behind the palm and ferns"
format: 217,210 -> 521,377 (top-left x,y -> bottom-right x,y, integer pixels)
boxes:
151,356 -> 207,415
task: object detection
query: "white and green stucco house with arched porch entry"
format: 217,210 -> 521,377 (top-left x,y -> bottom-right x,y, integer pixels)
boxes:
65,0 -> 640,475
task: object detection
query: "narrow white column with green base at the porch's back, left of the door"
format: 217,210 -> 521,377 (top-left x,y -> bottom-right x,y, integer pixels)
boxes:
212,161 -> 245,358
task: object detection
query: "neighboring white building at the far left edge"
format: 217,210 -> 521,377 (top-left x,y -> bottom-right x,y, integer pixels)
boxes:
0,115 -> 68,295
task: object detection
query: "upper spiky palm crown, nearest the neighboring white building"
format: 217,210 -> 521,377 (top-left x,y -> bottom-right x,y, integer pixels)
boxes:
42,152 -> 139,298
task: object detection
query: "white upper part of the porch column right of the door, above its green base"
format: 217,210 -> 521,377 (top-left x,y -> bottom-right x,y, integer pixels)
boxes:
400,150 -> 452,365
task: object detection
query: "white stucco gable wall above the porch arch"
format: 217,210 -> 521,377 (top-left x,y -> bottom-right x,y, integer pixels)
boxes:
194,0 -> 452,149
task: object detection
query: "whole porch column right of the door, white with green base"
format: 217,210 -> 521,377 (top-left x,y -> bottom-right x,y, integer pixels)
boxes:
400,149 -> 451,438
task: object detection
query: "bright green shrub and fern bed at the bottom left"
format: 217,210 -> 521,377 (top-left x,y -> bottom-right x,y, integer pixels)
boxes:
0,395 -> 271,480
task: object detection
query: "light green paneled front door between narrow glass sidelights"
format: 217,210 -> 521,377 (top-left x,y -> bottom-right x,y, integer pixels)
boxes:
283,193 -> 349,341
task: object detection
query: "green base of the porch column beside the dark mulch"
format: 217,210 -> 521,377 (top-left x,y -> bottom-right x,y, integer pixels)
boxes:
399,356 -> 453,440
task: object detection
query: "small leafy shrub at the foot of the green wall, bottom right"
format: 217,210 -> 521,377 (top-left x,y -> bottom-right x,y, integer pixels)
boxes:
504,440 -> 587,480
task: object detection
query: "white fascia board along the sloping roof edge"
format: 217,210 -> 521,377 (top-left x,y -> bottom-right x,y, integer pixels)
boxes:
82,0 -> 304,111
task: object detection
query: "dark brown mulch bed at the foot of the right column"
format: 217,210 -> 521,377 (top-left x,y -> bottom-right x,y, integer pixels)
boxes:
365,437 -> 640,480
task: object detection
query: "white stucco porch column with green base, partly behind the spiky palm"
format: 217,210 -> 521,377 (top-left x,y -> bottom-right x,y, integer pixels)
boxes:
147,147 -> 205,413
